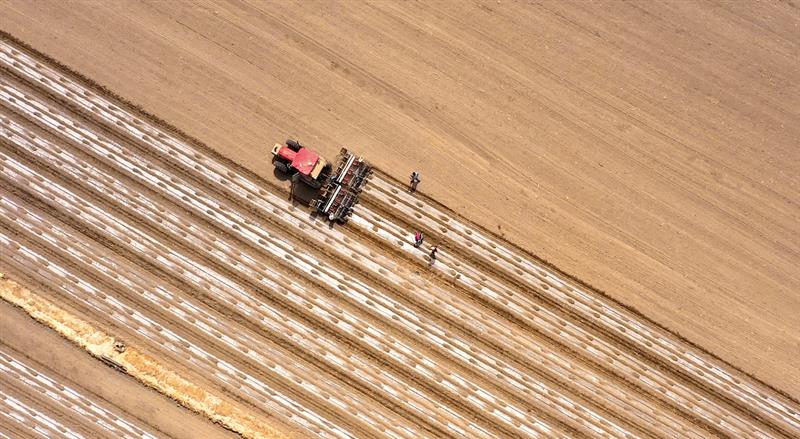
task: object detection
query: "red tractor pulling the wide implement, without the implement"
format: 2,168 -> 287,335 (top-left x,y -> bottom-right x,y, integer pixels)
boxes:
272,139 -> 331,189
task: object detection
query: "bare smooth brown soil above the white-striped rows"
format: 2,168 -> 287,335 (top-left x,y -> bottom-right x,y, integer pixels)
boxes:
2,2 -> 800,434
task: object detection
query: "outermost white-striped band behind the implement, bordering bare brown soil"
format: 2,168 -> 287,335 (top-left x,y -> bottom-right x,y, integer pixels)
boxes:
364,175 -> 798,436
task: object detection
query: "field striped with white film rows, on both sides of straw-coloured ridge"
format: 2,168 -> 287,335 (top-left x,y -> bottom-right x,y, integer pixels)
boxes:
0,1 -> 800,438
